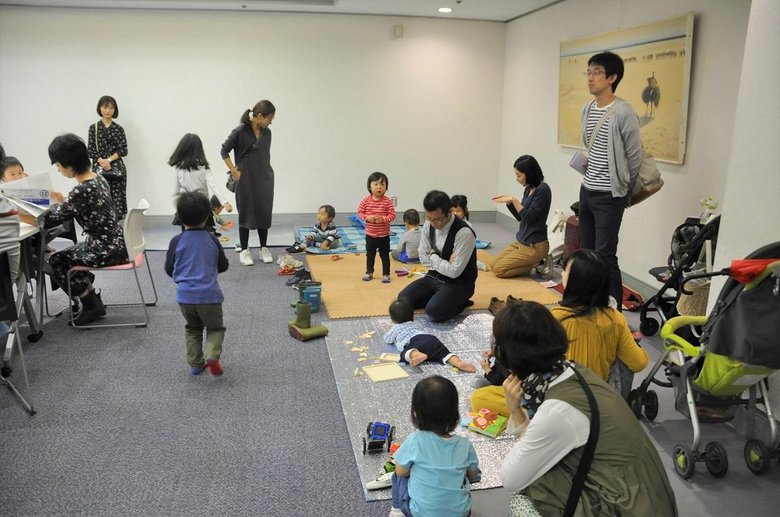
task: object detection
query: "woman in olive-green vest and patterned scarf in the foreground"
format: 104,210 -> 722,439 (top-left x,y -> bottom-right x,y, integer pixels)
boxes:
493,301 -> 677,516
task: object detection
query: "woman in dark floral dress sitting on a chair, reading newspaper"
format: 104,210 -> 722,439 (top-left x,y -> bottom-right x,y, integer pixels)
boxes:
25,133 -> 128,325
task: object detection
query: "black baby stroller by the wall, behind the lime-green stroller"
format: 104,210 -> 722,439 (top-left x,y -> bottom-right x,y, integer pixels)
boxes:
639,215 -> 720,336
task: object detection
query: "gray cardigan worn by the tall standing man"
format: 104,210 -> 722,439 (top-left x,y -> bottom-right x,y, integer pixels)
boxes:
582,97 -> 642,197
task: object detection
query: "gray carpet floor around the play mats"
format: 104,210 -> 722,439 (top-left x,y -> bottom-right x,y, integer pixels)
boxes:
0,225 -> 780,517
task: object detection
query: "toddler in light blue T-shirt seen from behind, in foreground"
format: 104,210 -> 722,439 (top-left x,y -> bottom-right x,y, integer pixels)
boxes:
390,375 -> 481,517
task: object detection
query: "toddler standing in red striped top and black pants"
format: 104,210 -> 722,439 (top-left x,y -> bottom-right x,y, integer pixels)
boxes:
357,172 -> 395,284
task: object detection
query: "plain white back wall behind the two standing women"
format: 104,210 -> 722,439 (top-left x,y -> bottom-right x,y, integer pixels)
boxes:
0,7 -> 506,214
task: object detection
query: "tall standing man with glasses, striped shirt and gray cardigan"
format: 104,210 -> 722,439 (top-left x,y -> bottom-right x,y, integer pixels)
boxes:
579,52 -> 642,310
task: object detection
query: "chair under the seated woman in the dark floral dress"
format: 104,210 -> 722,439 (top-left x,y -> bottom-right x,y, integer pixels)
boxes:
67,199 -> 157,329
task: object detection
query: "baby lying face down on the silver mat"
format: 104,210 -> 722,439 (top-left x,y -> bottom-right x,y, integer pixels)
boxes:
385,299 -> 477,373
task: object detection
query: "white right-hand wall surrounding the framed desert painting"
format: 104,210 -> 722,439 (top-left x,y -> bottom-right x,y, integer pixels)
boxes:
499,0 -> 756,288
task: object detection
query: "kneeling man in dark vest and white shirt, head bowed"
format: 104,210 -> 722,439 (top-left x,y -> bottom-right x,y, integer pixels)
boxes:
398,190 -> 477,322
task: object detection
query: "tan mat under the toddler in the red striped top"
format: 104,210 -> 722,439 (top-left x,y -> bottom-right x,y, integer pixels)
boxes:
306,250 -> 560,319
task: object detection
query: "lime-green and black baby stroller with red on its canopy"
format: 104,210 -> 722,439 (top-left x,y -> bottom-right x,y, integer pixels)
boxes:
629,242 -> 780,479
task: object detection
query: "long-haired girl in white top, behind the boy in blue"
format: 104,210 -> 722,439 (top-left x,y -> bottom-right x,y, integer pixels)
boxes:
168,133 -> 233,228
